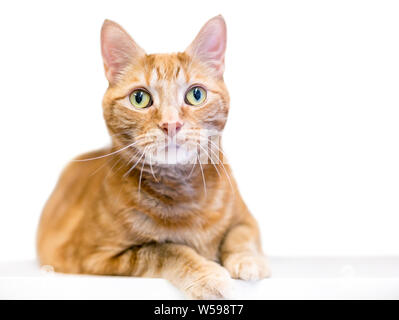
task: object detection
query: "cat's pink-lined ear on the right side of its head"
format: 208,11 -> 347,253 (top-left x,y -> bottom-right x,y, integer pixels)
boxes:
186,15 -> 227,77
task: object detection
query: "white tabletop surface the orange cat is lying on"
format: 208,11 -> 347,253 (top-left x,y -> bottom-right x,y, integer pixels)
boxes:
0,256 -> 399,299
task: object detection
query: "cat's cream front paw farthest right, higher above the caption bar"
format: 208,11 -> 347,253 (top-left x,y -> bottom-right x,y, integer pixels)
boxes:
223,253 -> 270,280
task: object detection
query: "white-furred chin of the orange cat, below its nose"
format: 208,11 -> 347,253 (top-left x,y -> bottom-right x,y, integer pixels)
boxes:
151,145 -> 197,166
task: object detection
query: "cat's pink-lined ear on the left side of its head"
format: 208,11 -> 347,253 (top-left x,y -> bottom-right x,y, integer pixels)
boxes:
101,20 -> 145,84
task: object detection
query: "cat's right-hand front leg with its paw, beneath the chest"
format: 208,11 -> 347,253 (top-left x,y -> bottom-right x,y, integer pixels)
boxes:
220,213 -> 270,280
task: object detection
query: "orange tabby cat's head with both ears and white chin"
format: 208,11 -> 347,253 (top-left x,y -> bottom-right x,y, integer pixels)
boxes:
101,16 -> 229,164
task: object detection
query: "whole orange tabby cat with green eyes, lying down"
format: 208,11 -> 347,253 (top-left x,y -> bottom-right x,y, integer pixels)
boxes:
38,16 -> 269,299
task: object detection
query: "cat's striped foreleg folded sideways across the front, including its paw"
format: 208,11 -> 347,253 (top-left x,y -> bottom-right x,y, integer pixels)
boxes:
84,243 -> 232,299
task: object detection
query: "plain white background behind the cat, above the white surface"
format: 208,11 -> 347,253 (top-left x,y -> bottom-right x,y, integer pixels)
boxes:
0,0 -> 399,260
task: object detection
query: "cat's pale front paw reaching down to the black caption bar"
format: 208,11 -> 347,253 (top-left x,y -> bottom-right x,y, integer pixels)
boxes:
184,263 -> 233,300
